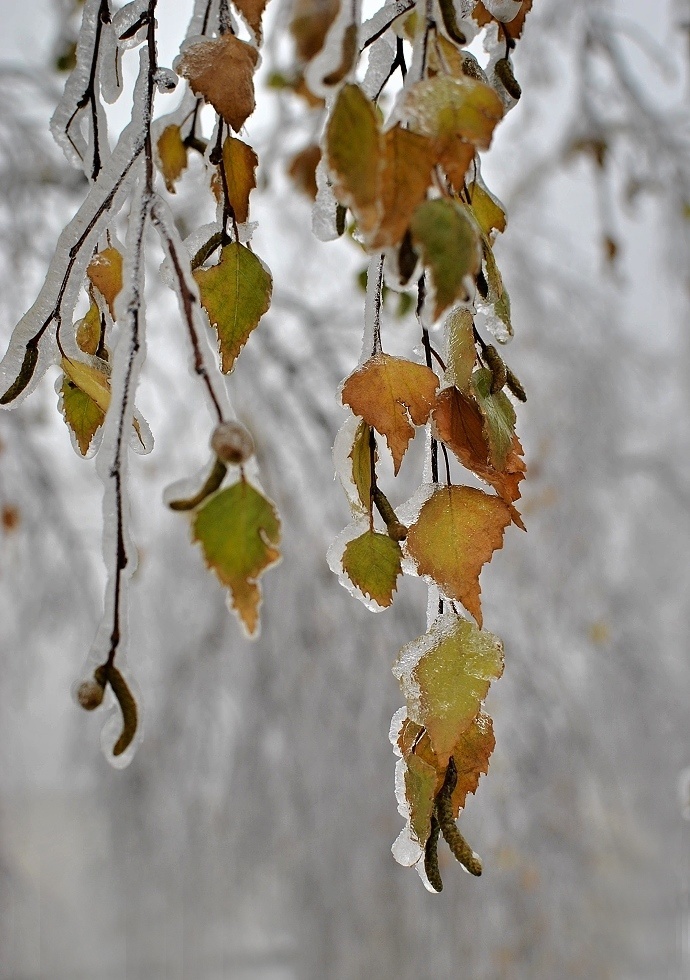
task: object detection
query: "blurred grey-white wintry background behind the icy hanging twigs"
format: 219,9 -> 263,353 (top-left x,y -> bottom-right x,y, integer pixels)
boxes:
0,0 -> 690,980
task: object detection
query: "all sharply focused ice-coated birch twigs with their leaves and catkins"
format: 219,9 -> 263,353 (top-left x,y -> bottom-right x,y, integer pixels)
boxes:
0,0 -> 531,890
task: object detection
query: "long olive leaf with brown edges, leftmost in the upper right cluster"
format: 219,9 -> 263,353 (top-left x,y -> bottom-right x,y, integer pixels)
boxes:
325,85 -> 383,234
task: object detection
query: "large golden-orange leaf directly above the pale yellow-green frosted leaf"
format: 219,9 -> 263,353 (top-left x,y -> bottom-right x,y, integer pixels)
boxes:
406,486 -> 512,626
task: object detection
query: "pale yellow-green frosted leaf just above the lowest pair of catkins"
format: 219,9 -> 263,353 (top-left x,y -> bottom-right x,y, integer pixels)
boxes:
393,613 -> 503,760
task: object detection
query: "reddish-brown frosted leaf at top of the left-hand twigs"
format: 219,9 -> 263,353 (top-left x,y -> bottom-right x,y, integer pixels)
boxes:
177,33 -> 259,132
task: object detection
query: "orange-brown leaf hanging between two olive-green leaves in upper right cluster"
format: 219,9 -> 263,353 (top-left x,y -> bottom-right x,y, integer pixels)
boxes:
370,124 -> 436,249
